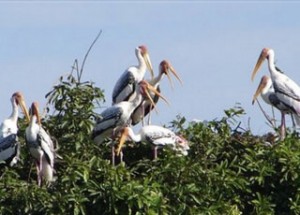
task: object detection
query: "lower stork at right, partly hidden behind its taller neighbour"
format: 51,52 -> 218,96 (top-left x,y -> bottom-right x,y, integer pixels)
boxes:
252,75 -> 300,139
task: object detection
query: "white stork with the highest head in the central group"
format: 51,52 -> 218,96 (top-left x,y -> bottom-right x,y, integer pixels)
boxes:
112,45 -> 154,105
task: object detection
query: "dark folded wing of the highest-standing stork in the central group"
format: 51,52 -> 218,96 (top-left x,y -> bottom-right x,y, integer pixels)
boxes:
112,71 -> 136,104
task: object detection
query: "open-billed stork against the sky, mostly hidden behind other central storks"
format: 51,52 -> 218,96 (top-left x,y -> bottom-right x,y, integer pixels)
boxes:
132,60 -> 182,125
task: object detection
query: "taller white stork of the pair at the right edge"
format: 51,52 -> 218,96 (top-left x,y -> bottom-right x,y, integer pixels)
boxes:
251,48 -> 300,140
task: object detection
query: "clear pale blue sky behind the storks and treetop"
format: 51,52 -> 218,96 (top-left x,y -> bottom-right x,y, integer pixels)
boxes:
0,1 -> 300,134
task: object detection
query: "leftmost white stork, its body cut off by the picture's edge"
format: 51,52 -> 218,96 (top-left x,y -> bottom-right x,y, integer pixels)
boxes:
0,91 -> 29,166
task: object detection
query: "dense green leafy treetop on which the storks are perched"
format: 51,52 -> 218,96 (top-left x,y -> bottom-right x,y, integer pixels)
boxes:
0,59 -> 300,214
